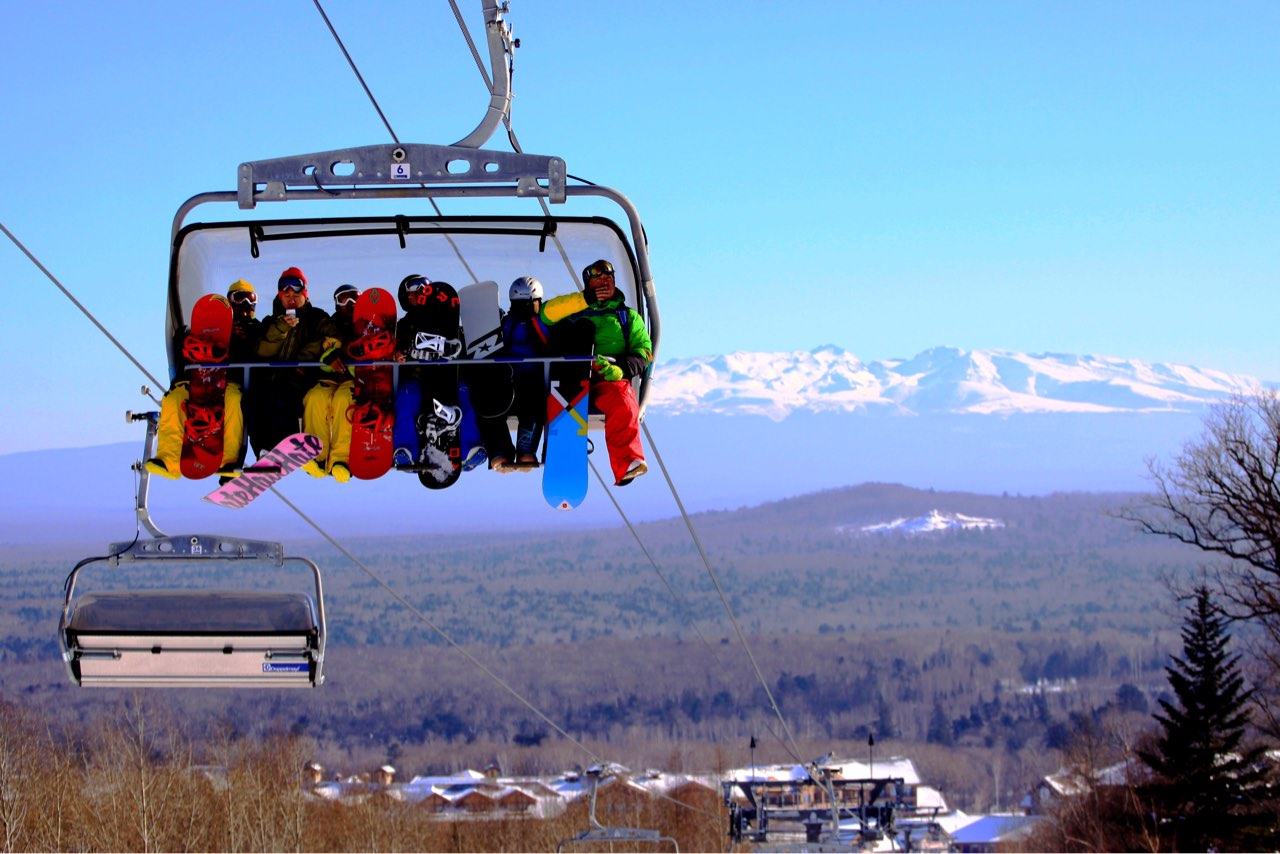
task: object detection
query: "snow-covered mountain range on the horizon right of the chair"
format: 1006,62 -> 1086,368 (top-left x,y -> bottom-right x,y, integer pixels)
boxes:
649,346 -> 1261,421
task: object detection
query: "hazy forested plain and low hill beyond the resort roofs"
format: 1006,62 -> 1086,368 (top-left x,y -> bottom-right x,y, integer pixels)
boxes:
0,484 -> 1197,807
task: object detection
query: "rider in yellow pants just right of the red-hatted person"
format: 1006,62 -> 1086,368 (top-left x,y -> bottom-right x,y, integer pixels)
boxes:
302,284 -> 360,483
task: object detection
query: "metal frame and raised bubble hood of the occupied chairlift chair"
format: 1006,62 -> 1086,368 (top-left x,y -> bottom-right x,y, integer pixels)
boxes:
165,143 -> 660,428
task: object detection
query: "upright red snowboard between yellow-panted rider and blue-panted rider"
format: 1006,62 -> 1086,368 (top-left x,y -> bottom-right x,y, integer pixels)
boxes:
347,288 -> 396,480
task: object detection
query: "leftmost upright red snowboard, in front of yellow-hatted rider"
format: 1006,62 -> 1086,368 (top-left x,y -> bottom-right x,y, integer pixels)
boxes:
180,293 -> 236,480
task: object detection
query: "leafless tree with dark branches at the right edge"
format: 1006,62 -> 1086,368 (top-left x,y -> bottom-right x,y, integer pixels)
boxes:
1121,389 -> 1280,734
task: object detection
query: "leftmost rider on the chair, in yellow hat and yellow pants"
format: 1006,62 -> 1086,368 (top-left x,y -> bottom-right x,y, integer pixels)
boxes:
143,279 -> 257,483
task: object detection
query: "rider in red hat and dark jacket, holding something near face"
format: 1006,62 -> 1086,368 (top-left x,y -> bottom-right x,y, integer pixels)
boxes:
248,266 -> 340,457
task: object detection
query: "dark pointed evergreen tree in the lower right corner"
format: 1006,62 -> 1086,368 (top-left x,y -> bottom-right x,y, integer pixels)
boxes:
1138,585 -> 1275,850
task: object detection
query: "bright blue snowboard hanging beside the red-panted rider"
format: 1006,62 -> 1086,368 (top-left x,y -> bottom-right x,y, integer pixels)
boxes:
543,361 -> 591,510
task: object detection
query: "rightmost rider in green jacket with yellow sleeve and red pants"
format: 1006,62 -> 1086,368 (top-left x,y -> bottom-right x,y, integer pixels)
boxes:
540,260 -> 653,487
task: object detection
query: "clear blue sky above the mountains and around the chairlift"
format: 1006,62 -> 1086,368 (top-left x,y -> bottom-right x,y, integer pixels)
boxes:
0,0 -> 1280,453
